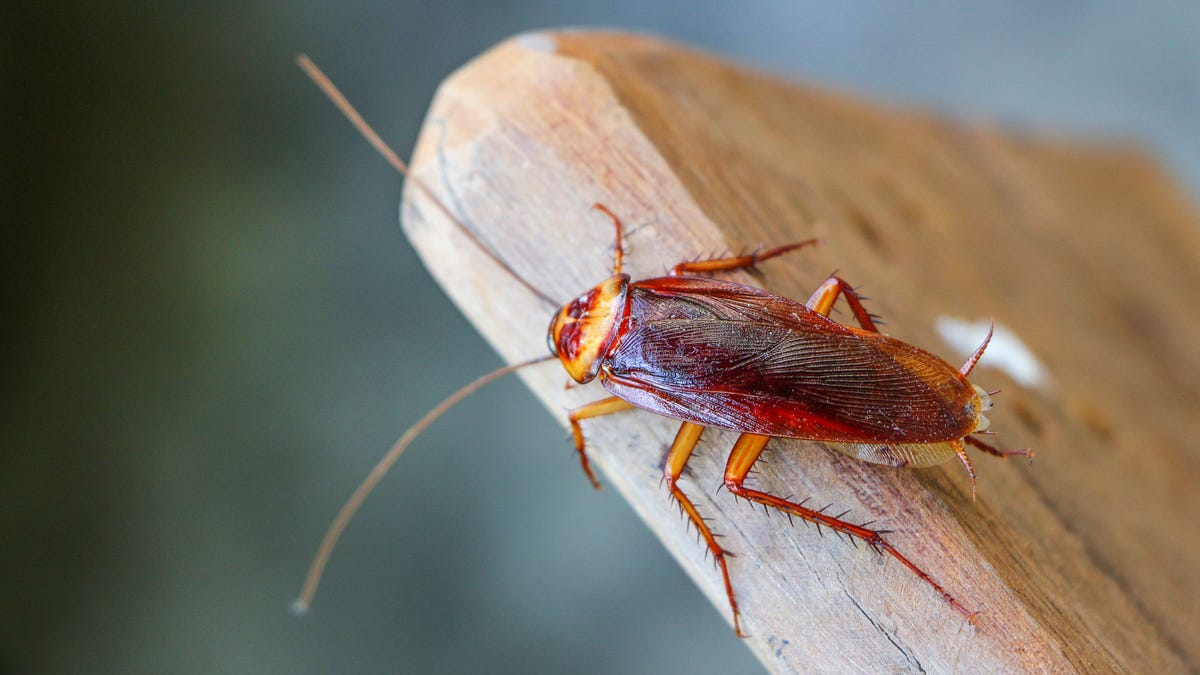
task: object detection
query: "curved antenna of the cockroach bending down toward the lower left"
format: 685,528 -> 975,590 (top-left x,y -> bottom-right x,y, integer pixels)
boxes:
292,356 -> 554,614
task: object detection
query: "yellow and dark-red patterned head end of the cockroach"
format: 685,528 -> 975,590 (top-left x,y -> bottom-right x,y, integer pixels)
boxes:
546,274 -> 629,383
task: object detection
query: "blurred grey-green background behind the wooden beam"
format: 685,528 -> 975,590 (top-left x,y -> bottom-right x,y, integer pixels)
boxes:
0,0 -> 1200,674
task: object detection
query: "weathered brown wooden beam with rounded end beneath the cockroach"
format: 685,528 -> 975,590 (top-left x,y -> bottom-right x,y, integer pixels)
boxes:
403,32 -> 1200,673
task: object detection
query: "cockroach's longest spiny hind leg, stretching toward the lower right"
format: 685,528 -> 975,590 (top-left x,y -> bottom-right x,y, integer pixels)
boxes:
725,434 -> 976,623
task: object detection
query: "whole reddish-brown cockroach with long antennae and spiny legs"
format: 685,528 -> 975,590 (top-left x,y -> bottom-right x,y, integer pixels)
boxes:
295,55 -> 1033,637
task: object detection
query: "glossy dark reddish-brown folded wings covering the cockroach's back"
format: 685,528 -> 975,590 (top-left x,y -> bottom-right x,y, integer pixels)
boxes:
601,277 -> 976,444
